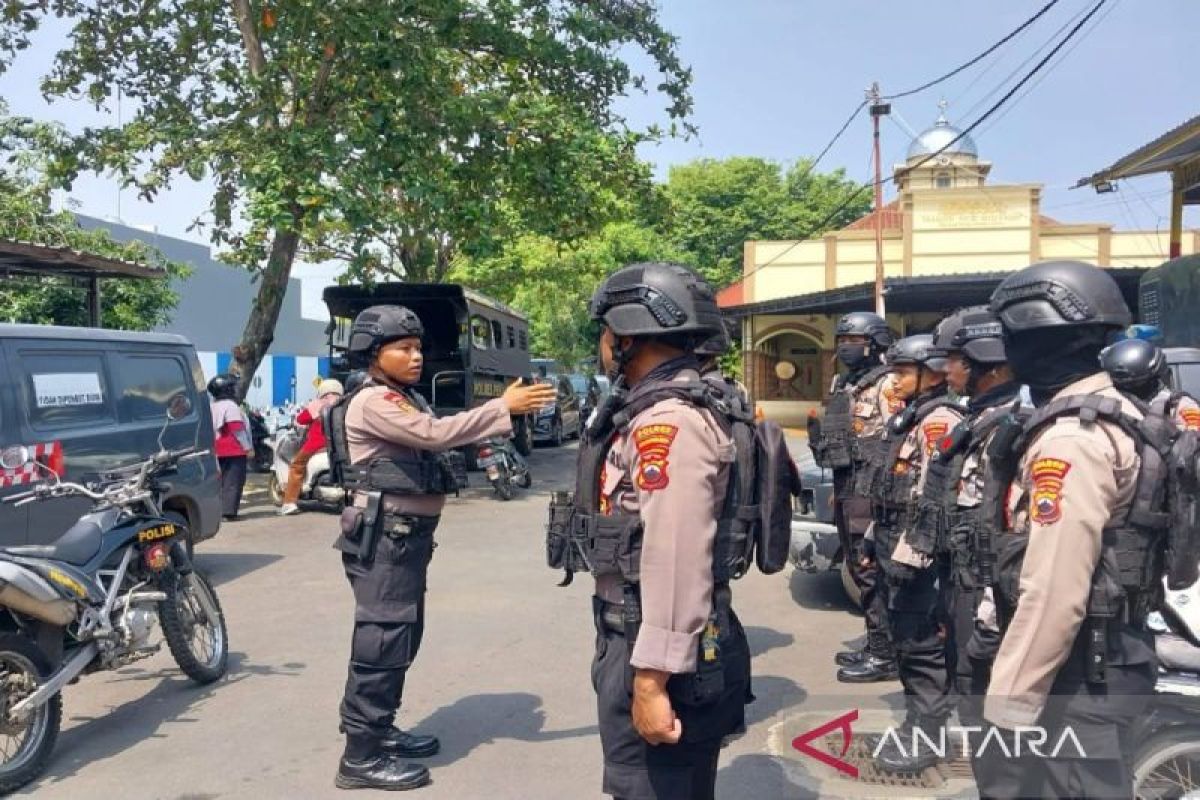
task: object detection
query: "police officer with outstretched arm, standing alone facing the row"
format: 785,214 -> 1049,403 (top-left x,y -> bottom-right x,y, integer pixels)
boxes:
326,306 -> 554,789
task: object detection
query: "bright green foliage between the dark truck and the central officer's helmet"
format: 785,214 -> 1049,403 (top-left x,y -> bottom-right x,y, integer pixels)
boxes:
450,222 -> 690,365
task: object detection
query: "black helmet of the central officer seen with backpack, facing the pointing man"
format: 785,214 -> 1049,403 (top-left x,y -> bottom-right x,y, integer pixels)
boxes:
589,261 -> 725,339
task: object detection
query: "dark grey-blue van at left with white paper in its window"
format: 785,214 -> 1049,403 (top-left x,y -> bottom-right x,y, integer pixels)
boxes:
0,324 -> 221,545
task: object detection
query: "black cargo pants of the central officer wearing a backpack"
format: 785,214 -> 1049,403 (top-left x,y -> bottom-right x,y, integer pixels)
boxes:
592,597 -> 752,800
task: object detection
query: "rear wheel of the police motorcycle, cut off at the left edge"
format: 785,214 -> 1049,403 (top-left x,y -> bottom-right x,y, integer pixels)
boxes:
0,633 -> 62,794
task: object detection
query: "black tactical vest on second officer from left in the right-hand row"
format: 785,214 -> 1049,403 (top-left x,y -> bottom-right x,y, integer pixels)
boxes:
856,396 -> 961,563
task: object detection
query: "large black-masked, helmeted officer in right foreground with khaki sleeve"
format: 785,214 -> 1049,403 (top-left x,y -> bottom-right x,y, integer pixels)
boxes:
980,261 -> 1163,798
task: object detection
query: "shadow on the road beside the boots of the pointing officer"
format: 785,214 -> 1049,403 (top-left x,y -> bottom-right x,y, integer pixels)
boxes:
413,692 -> 600,766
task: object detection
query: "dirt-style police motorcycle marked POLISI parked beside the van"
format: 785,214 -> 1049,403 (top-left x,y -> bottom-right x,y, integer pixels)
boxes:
0,393 -> 229,793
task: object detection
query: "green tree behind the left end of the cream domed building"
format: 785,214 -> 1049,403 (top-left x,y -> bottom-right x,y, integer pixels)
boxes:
665,157 -> 870,287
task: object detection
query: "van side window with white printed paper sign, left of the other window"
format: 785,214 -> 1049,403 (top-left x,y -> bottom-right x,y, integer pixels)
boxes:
20,351 -> 116,429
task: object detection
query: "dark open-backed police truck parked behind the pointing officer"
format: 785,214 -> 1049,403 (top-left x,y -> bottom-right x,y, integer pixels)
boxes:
323,283 -> 533,456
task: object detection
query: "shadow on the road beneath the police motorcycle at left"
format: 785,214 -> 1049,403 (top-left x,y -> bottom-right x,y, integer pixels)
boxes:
22,652 -> 305,794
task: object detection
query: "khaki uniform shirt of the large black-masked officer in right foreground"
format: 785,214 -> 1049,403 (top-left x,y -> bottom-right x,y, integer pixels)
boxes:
984,373 -> 1141,728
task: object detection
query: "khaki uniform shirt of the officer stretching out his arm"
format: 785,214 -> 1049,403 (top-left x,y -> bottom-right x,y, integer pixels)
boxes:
346,383 -> 512,517
